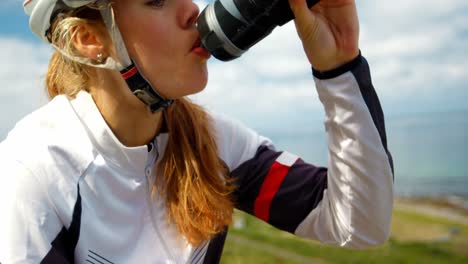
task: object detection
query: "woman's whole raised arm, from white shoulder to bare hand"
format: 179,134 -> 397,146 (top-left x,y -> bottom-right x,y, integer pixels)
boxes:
208,0 -> 393,253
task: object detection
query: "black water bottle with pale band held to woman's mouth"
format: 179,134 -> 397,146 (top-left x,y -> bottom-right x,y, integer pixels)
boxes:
197,0 -> 319,61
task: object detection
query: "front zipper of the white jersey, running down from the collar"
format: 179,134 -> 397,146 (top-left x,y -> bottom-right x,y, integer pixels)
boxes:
145,139 -> 177,263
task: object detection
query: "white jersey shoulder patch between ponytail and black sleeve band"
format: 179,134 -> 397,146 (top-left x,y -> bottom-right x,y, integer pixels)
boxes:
208,112 -> 273,171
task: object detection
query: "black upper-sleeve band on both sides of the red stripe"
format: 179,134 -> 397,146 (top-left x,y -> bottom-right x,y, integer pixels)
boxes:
231,146 -> 327,233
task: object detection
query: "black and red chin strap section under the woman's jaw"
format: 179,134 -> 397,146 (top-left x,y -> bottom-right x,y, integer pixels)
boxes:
120,62 -> 174,113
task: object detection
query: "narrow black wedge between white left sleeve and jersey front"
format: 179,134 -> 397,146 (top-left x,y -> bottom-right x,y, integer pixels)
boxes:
41,185 -> 81,264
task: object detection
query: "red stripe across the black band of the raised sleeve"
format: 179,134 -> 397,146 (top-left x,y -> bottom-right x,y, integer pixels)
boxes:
254,161 -> 290,222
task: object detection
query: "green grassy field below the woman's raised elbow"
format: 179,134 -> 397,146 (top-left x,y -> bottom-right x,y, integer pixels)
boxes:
221,202 -> 468,264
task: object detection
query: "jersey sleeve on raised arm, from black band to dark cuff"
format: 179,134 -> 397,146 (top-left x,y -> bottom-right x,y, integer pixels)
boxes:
231,55 -> 393,248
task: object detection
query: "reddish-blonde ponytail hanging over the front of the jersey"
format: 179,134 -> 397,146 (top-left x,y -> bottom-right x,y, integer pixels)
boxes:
159,98 -> 234,246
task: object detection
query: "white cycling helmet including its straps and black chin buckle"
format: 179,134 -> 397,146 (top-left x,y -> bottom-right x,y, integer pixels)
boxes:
23,0 -> 173,112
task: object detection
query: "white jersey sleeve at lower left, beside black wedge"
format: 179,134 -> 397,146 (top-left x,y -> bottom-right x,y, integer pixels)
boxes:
0,155 -> 63,264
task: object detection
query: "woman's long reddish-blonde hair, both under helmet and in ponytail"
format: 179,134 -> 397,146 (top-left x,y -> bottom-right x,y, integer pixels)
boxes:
46,8 -> 233,246
